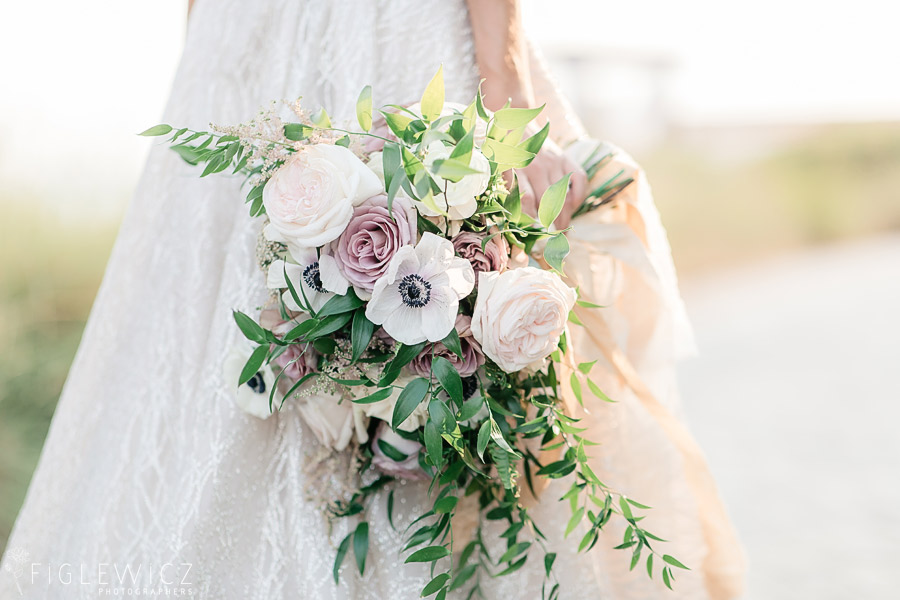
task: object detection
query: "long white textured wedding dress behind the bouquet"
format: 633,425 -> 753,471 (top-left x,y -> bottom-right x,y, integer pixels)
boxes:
0,0 -> 742,600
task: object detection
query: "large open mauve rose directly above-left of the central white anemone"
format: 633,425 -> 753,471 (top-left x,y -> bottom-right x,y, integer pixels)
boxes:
332,194 -> 418,300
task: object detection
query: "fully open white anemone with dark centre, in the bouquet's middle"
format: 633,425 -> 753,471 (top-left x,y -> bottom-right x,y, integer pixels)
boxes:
366,233 -> 475,344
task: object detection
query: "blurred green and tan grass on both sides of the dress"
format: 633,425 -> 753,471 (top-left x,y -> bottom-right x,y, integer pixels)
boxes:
0,124 -> 900,551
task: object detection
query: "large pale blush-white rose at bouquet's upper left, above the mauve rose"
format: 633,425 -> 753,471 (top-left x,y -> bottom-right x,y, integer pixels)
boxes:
263,144 -> 382,248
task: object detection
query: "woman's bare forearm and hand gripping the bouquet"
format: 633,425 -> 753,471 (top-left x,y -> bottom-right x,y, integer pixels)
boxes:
466,0 -> 587,227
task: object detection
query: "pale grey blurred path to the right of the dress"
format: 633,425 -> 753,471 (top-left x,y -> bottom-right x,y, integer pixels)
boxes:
681,235 -> 900,600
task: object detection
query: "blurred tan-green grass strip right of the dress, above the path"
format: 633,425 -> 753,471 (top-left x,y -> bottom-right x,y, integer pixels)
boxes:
642,124 -> 900,271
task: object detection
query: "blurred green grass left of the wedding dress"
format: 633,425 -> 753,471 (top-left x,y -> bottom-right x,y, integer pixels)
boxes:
0,201 -> 115,551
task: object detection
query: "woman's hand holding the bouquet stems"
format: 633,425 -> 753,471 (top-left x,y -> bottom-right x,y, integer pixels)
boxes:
516,138 -> 588,229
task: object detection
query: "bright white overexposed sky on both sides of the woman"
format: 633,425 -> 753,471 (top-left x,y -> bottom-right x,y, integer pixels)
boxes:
0,0 -> 900,220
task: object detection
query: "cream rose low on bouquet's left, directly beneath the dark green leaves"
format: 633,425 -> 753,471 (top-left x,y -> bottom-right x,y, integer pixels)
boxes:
299,392 -> 369,452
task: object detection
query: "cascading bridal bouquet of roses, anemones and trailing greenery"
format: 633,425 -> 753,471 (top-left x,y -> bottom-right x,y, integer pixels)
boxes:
144,71 -> 685,599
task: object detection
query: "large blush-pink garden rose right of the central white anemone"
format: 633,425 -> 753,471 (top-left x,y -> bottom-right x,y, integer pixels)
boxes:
472,267 -> 576,373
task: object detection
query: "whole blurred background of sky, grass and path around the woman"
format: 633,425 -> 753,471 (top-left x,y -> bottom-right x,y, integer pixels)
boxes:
0,0 -> 900,600
